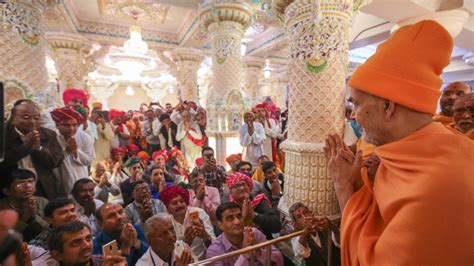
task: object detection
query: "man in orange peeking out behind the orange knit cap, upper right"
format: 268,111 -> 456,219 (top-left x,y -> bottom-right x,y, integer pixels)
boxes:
433,82 -> 471,126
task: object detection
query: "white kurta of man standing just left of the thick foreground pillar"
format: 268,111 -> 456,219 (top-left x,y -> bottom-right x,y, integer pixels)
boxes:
239,122 -> 266,167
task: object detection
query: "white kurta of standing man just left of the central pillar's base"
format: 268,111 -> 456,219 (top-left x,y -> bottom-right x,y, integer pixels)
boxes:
176,122 -> 202,169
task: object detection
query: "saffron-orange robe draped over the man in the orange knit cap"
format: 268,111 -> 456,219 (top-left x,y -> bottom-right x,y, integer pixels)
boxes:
341,123 -> 474,265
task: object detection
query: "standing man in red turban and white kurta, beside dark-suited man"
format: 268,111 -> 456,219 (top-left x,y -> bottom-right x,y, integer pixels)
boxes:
51,107 -> 95,193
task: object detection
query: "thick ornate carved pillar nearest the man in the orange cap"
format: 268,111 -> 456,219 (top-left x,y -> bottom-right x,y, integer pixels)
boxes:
273,0 -> 355,216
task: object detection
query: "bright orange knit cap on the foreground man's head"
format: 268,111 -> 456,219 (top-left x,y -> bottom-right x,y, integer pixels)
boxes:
349,20 -> 453,114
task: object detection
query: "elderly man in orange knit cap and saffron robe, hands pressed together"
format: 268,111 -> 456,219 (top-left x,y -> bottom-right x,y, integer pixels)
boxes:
324,20 -> 474,265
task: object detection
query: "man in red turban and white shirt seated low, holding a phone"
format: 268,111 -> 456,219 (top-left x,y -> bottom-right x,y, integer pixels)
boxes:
160,186 -> 216,259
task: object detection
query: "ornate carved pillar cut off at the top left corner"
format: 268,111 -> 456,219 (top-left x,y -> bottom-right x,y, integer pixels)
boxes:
0,0 -> 48,104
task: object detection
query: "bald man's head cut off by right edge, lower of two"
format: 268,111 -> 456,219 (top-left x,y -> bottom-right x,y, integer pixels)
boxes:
453,92 -> 474,140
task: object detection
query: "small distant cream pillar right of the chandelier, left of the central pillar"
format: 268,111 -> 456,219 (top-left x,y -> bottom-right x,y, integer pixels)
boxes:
174,48 -> 204,102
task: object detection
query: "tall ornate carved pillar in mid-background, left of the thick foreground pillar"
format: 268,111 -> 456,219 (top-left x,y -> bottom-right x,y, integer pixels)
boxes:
199,0 -> 253,165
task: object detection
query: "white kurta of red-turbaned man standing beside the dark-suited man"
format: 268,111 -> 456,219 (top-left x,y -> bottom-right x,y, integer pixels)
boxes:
53,130 -> 95,194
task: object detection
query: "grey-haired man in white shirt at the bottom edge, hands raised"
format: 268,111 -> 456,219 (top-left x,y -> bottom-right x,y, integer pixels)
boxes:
136,215 -> 194,266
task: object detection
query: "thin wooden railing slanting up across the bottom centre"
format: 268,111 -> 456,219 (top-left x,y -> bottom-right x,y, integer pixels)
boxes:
190,230 -> 305,265
